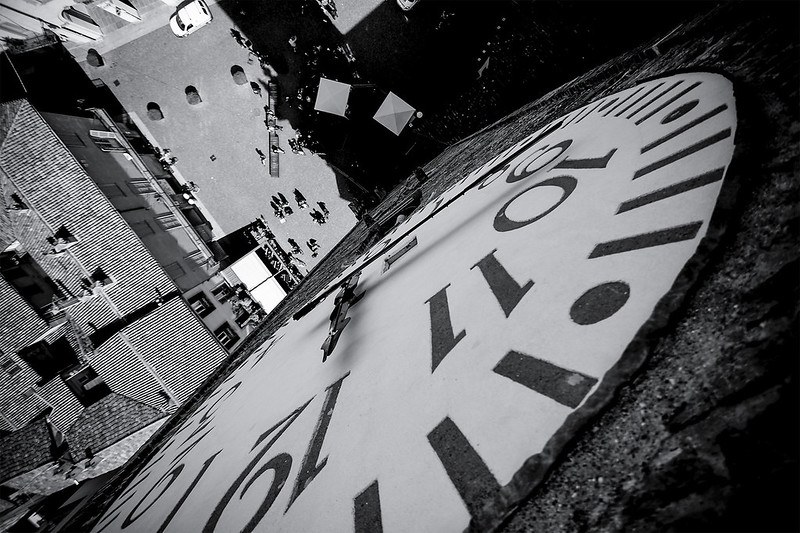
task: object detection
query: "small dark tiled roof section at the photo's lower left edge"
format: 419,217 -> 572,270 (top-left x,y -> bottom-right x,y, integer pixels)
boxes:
0,417 -> 53,482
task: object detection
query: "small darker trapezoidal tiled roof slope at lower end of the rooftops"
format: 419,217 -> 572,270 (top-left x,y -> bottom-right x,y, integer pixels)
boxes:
66,392 -> 167,460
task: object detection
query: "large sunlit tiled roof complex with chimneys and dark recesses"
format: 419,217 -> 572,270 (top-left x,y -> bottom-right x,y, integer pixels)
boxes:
0,100 -> 226,481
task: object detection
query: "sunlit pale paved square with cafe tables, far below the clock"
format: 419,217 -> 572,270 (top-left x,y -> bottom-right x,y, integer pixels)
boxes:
82,5 -> 356,267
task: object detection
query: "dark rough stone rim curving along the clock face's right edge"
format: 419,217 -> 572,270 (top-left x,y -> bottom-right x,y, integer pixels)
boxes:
465,66 -> 754,533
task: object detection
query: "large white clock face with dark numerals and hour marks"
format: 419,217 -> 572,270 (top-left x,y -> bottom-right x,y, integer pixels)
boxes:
93,73 -> 736,532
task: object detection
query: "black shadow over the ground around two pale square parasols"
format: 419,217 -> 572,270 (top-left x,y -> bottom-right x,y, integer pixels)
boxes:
218,0 -> 713,197
